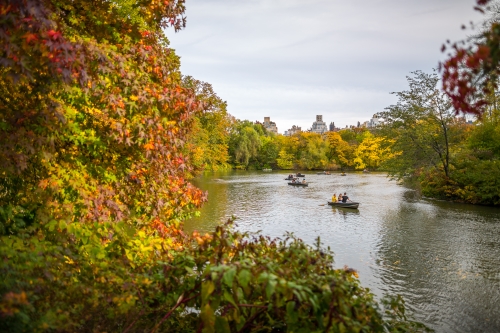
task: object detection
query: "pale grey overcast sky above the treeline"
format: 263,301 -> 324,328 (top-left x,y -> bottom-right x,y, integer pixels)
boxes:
167,0 -> 481,133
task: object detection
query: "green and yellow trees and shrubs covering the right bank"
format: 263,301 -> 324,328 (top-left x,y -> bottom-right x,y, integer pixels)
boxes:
378,72 -> 500,205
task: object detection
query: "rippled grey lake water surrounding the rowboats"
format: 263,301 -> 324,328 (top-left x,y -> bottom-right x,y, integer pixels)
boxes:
185,171 -> 500,332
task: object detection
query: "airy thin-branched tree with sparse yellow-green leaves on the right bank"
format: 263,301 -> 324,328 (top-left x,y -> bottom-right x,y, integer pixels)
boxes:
379,71 -> 455,177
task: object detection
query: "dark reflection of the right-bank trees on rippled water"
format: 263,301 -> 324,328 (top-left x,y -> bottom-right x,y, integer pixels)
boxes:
375,203 -> 500,332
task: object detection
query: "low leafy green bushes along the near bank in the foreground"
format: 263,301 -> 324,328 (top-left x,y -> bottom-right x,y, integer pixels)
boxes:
0,222 -> 430,332
